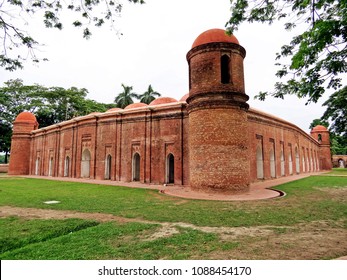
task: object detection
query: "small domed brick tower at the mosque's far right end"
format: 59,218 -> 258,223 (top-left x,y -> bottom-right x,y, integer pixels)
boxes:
311,125 -> 333,170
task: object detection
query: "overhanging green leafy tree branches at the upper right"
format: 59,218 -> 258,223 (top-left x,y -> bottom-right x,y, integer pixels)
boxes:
226,0 -> 347,103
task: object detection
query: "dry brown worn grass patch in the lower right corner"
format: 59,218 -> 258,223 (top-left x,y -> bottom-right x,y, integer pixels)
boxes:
209,221 -> 347,260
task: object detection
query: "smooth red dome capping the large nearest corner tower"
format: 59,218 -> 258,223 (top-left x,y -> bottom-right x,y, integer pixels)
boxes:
192,28 -> 239,48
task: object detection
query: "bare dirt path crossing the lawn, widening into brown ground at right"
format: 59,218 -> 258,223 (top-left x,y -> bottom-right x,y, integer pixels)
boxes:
0,205 -> 347,259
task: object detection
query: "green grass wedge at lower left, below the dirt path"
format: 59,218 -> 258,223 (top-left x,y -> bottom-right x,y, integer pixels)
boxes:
1,222 -> 235,260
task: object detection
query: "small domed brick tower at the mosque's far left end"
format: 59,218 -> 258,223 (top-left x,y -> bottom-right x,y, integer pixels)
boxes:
8,112 -> 39,175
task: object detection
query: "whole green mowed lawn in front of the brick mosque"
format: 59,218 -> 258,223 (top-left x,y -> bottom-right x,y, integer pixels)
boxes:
0,167 -> 347,259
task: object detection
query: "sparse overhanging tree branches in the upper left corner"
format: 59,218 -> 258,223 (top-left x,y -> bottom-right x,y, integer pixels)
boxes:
0,0 -> 144,71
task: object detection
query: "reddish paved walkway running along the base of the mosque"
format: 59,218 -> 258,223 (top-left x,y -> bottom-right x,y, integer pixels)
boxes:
17,172 -> 328,201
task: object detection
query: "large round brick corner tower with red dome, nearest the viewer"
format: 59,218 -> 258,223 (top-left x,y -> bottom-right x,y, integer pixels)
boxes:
187,29 -> 250,193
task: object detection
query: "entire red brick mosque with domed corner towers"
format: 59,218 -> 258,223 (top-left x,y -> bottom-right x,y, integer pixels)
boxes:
9,29 -> 332,193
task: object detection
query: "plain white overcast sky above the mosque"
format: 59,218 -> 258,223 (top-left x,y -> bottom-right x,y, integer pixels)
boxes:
0,0 -> 332,132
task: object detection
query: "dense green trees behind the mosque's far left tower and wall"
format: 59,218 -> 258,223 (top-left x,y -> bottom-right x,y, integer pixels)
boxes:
0,79 -> 113,159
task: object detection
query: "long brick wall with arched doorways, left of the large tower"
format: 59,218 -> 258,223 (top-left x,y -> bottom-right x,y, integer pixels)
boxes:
30,102 -> 189,185
